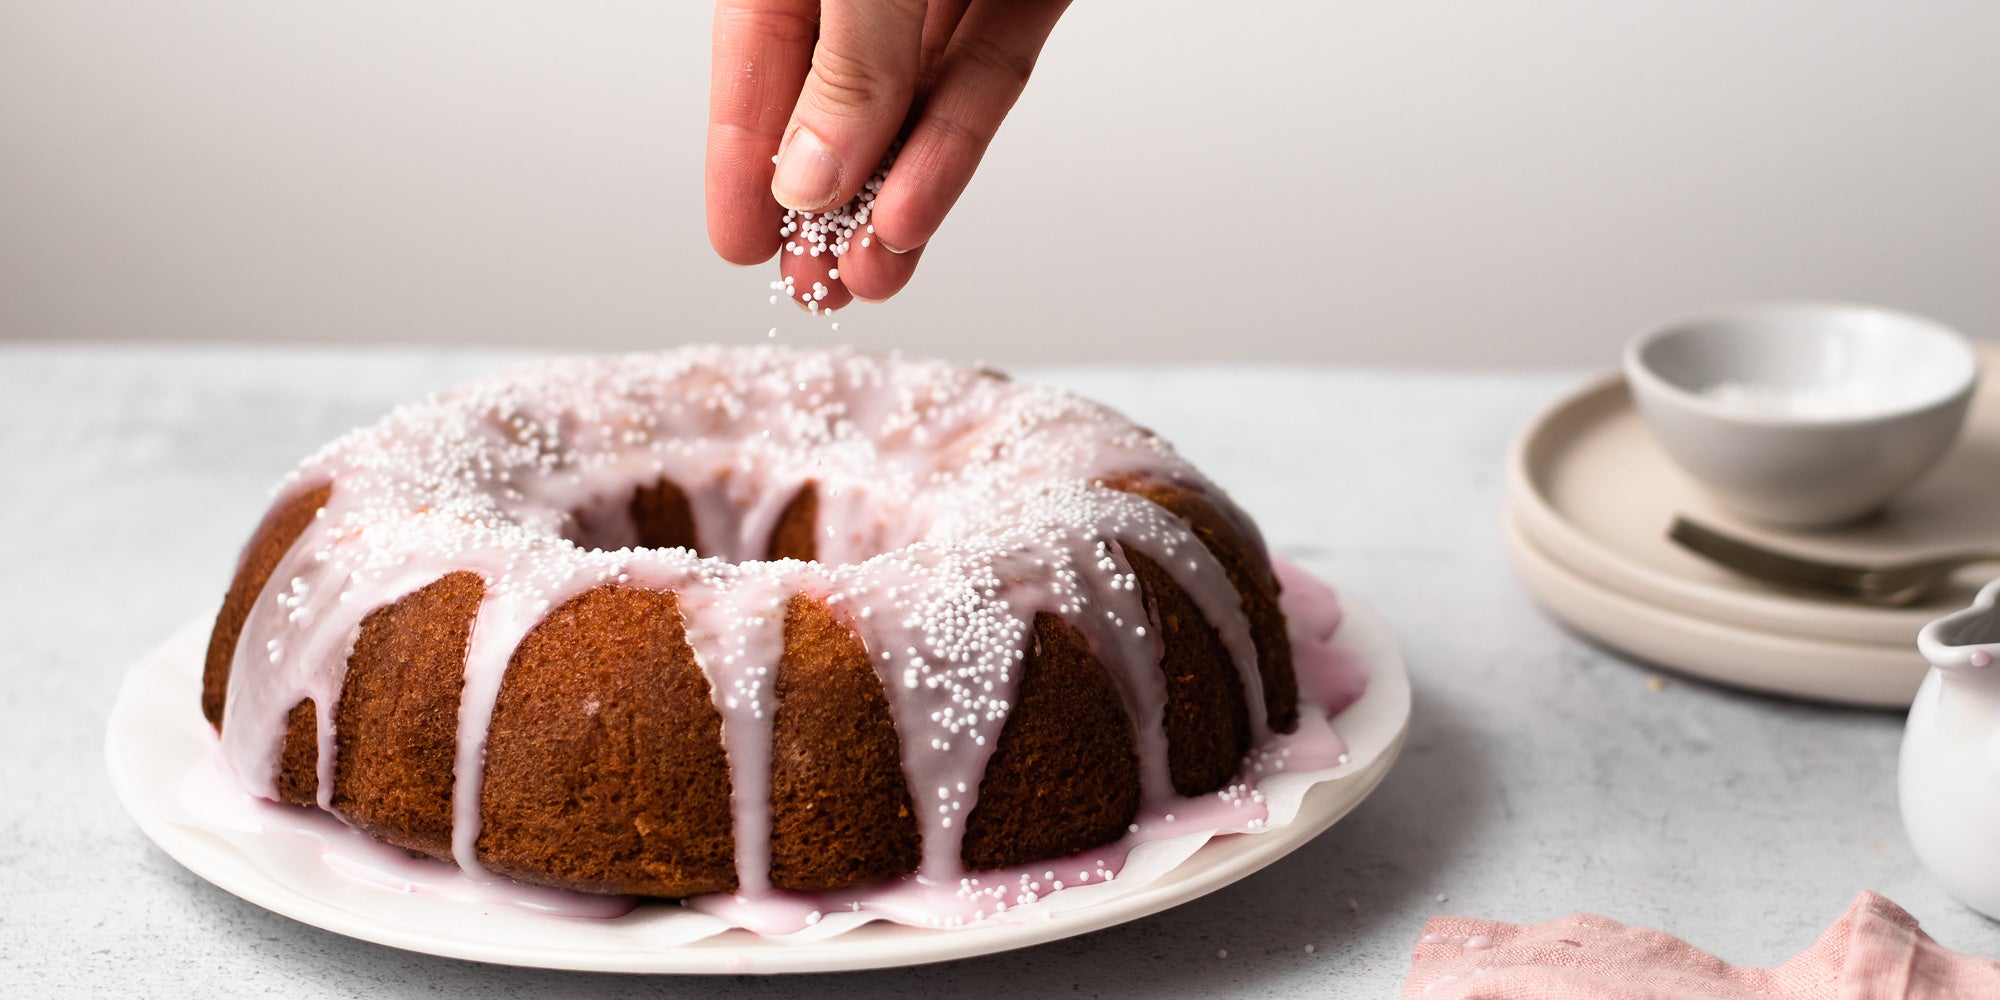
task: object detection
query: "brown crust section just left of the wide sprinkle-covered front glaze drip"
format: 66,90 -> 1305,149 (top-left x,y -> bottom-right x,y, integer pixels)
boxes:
770,596 -> 922,890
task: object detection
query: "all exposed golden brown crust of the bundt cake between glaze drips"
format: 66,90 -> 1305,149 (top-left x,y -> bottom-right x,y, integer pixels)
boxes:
218,478 -> 1296,896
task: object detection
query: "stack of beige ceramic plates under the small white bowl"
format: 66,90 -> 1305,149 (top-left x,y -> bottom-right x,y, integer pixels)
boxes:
1506,346 -> 2000,706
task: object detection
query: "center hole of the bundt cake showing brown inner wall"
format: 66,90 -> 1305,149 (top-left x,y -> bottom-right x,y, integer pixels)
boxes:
566,478 -> 820,562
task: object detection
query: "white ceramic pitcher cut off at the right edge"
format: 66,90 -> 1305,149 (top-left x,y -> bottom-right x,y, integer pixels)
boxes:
1896,580 -> 2000,920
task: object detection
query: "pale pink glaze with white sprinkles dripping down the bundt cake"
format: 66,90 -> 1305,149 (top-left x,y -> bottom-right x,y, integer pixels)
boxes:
211,348 -> 1360,926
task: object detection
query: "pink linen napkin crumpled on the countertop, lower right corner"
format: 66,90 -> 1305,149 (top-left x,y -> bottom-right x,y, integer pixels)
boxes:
1402,892 -> 2000,1000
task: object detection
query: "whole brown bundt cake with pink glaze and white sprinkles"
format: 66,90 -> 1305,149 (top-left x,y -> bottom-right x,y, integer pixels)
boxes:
202,348 -> 1296,912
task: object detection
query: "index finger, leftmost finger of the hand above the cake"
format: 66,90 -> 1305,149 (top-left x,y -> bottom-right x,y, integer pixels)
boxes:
704,0 -> 820,264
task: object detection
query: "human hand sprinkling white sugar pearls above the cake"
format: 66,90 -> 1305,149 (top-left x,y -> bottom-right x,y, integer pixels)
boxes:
706,0 -> 1070,308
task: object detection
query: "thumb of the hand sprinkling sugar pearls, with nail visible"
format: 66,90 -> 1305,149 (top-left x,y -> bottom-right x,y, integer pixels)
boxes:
770,0 -> 924,212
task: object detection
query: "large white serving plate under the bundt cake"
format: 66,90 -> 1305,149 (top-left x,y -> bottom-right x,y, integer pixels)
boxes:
104,598 -> 1410,972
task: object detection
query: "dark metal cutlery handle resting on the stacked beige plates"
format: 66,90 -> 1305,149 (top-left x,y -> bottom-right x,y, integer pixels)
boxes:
1666,516 -> 2000,608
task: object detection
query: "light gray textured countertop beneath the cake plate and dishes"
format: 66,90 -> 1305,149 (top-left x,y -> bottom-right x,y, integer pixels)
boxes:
0,346 -> 2000,1000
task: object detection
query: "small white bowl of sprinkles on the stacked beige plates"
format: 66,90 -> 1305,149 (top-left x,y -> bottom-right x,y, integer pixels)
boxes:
1624,302 -> 1980,528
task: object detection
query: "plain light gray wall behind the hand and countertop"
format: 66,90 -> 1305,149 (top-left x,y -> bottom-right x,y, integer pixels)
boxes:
0,0 -> 2000,364
